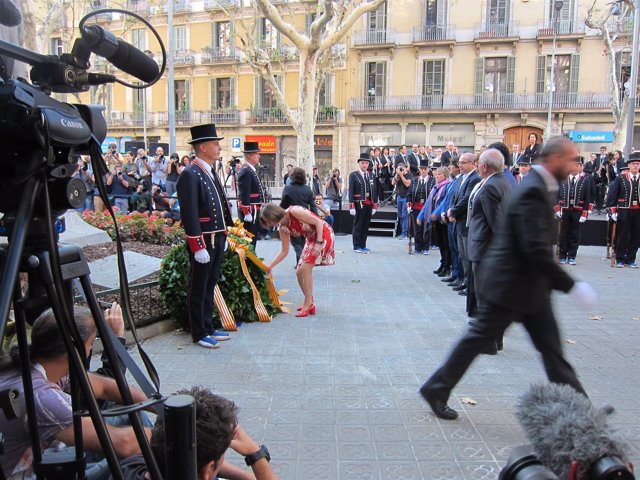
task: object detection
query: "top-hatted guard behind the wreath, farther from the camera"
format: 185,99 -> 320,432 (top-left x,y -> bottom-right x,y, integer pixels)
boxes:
238,142 -> 266,248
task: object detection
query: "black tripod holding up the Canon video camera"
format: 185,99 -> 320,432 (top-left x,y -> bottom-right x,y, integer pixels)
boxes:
0,174 -> 162,479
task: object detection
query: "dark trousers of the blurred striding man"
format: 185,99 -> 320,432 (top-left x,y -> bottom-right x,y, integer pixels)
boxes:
423,297 -> 586,402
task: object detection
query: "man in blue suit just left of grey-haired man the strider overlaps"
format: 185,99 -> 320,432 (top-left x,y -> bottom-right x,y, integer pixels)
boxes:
447,153 -> 480,295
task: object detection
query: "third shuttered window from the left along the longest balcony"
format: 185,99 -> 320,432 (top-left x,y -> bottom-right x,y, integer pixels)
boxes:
475,57 -> 515,106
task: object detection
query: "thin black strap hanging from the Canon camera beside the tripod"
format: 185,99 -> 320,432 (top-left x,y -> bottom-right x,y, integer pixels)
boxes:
91,142 -> 160,395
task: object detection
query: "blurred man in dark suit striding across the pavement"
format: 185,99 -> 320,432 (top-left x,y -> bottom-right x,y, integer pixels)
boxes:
420,137 -> 596,420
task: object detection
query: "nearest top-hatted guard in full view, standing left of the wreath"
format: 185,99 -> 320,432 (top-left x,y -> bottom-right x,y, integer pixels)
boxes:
176,123 -> 233,348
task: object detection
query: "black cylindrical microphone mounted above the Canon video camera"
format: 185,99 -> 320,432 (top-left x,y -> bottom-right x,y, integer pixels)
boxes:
82,25 -> 160,83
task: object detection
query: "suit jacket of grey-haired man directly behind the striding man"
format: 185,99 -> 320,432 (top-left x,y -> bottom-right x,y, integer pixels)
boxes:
467,172 -> 513,262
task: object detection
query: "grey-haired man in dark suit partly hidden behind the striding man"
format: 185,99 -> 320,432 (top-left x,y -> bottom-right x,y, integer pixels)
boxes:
467,148 -> 513,326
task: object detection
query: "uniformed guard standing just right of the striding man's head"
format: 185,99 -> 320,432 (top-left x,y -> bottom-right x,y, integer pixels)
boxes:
554,157 -> 596,265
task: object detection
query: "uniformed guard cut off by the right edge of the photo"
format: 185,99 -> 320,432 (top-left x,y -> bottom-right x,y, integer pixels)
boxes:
607,152 -> 640,268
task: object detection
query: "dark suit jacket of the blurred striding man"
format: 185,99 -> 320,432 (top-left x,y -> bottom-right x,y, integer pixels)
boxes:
476,169 -> 574,313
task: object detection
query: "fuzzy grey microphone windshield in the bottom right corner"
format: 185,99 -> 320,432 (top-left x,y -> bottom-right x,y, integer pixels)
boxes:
516,383 -> 635,480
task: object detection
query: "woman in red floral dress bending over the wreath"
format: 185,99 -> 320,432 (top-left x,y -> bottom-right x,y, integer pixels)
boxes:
260,203 -> 336,317
